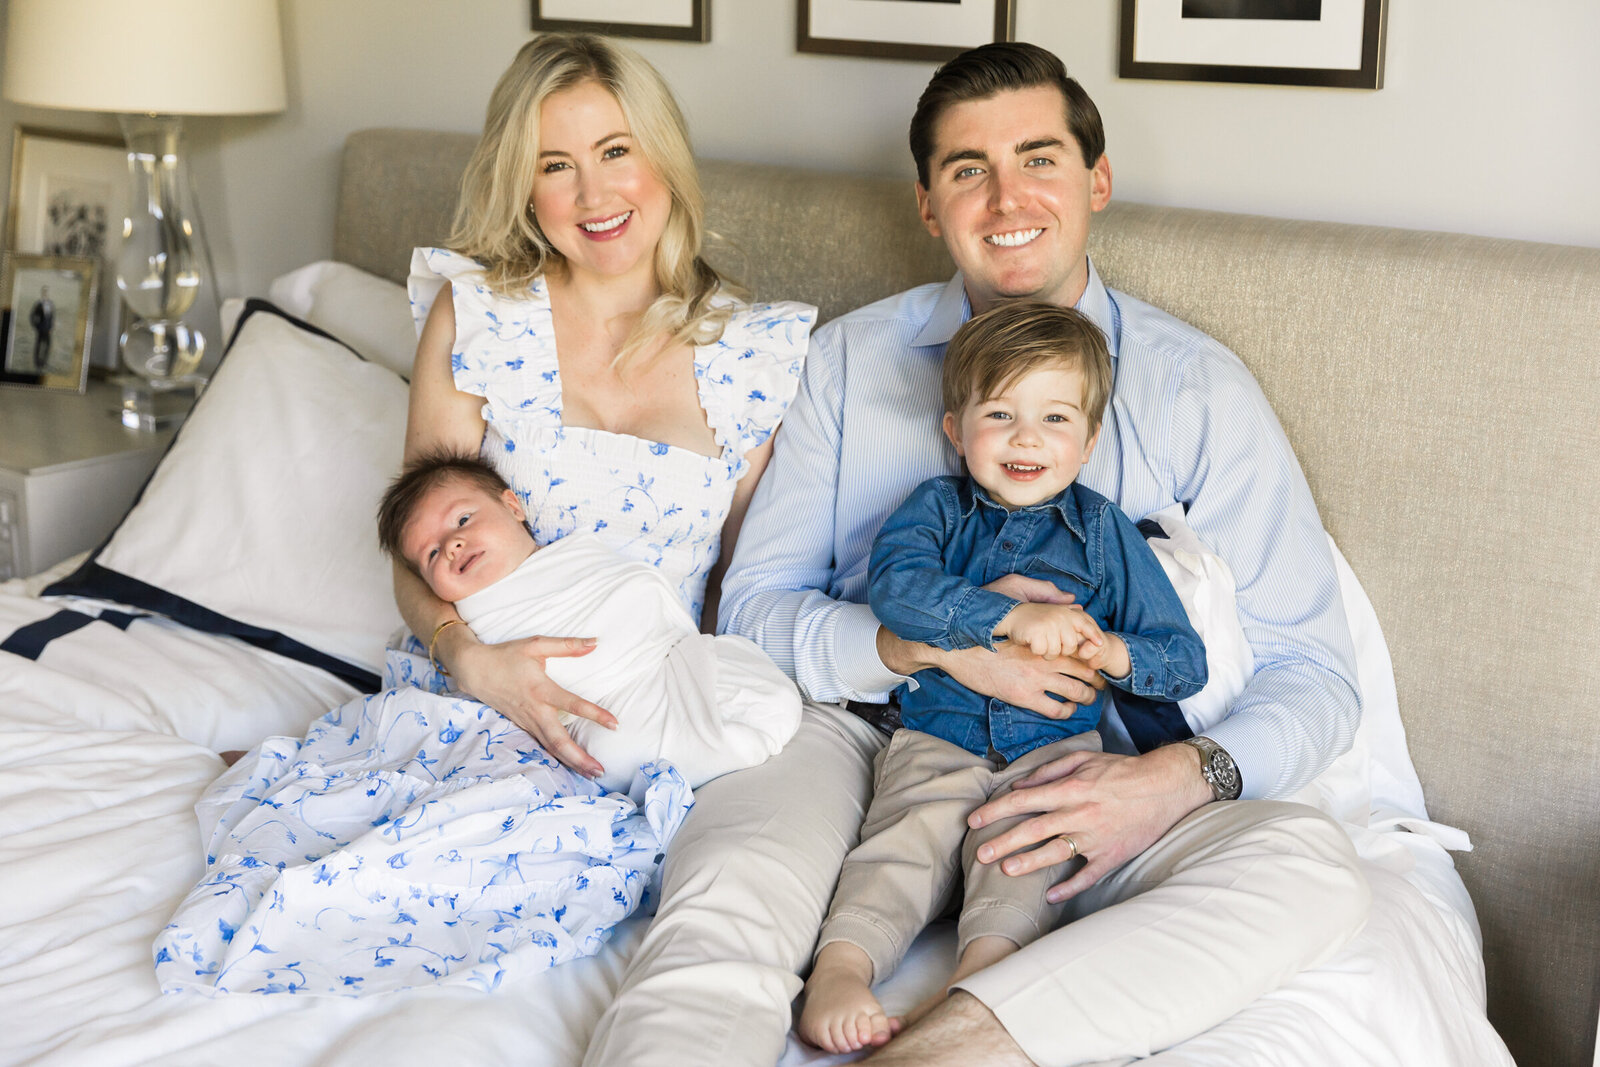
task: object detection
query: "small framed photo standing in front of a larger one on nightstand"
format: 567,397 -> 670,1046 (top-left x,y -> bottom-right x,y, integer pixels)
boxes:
0,253 -> 99,392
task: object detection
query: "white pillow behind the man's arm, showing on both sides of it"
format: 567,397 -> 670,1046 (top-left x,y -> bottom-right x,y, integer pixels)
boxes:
1147,504 -> 1467,848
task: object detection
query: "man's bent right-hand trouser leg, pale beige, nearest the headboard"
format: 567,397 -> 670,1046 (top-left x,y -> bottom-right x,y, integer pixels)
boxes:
957,800 -> 1371,1067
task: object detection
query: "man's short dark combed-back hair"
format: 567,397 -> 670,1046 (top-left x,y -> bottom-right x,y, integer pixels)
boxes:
910,42 -> 1106,189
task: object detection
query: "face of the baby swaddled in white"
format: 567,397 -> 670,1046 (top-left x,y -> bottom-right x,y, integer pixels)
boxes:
400,478 -> 538,603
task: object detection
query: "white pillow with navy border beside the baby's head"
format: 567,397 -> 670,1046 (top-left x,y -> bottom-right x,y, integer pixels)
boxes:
45,301 -> 406,691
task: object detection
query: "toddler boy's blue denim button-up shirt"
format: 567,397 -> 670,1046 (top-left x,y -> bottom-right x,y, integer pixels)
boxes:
870,477 -> 1206,760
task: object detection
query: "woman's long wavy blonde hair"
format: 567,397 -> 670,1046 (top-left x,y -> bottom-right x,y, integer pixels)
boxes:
448,34 -> 732,371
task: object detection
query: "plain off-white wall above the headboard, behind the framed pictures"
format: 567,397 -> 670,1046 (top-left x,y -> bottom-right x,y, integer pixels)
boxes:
147,0 -> 1600,293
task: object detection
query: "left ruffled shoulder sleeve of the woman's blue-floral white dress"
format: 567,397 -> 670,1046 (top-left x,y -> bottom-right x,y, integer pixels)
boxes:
406,248 -> 562,421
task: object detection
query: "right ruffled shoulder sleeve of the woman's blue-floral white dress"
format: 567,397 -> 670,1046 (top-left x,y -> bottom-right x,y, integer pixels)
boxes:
698,301 -> 816,464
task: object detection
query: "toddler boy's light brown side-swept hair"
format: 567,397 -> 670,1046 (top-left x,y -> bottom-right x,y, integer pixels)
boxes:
942,301 -> 1112,434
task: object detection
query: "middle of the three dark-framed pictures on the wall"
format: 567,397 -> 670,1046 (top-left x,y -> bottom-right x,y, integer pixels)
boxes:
797,0 -> 1016,62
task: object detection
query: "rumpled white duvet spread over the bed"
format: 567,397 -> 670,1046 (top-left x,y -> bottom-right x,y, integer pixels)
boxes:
0,556 -> 1510,1067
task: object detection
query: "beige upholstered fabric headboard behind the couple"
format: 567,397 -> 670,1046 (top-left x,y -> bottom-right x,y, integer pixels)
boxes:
336,130 -> 1600,1064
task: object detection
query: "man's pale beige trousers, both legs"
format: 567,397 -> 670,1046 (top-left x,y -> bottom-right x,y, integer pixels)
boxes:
584,702 -> 1368,1067
